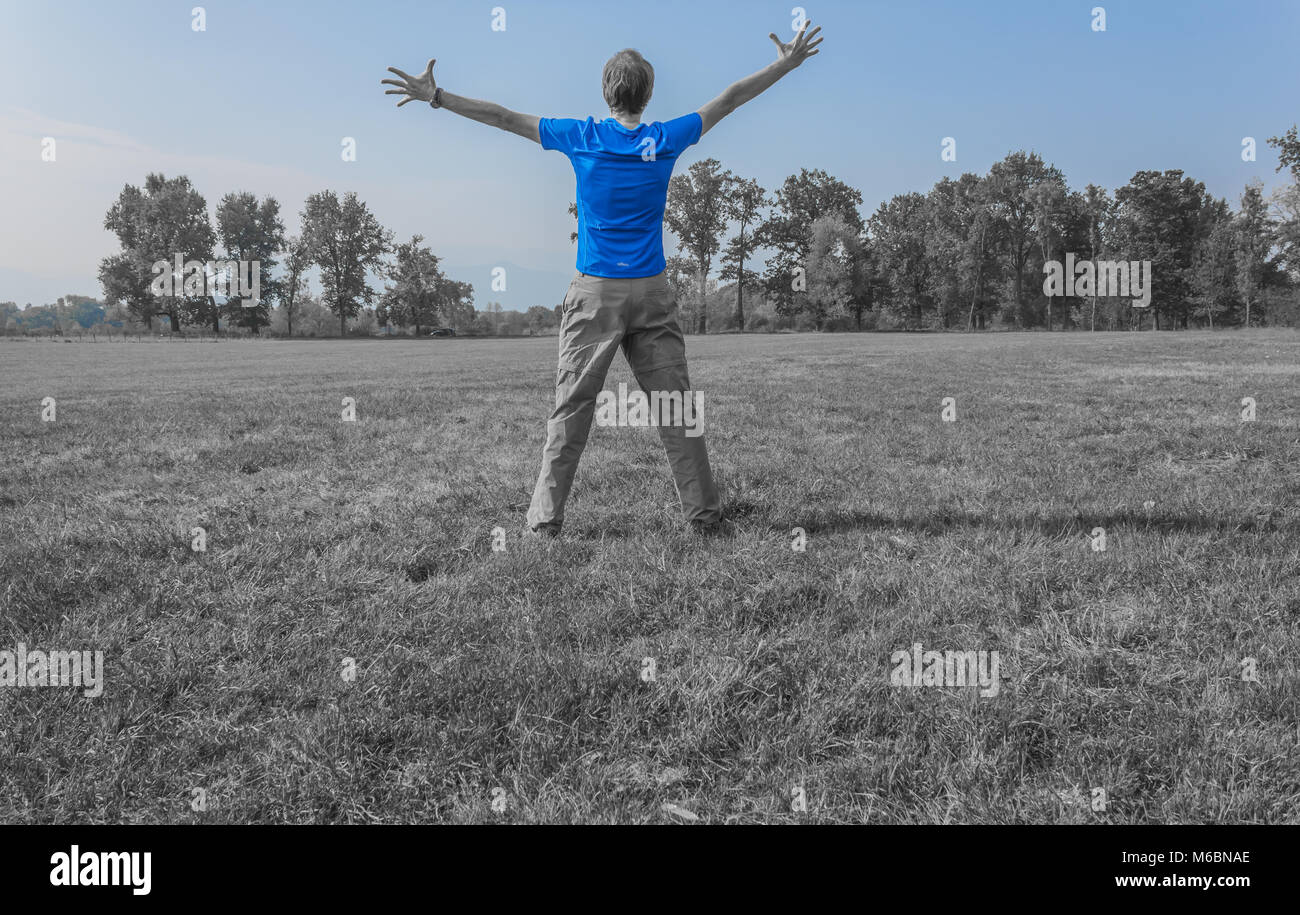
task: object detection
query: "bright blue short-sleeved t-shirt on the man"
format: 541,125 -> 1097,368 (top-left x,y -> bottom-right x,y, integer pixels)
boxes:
537,112 -> 705,277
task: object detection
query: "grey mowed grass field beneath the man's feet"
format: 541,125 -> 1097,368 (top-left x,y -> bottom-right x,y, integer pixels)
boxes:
0,331 -> 1300,823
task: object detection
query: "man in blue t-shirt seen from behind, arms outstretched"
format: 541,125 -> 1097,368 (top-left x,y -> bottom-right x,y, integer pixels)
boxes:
382,21 -> 822,537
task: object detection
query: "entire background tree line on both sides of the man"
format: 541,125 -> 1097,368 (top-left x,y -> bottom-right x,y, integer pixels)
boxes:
10,126 -> 1300,334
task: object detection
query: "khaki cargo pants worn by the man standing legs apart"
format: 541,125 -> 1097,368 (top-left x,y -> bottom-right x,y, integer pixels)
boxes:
528,273 -> 722,528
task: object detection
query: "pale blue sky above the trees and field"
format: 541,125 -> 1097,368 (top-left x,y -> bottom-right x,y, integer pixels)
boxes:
0,0 -> 1300,308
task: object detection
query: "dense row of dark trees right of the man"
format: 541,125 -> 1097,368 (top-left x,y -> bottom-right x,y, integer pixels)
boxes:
664,126 -> 1300,333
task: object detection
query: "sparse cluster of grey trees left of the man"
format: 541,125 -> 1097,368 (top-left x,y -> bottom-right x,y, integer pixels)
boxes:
89,174 -> 476,335
